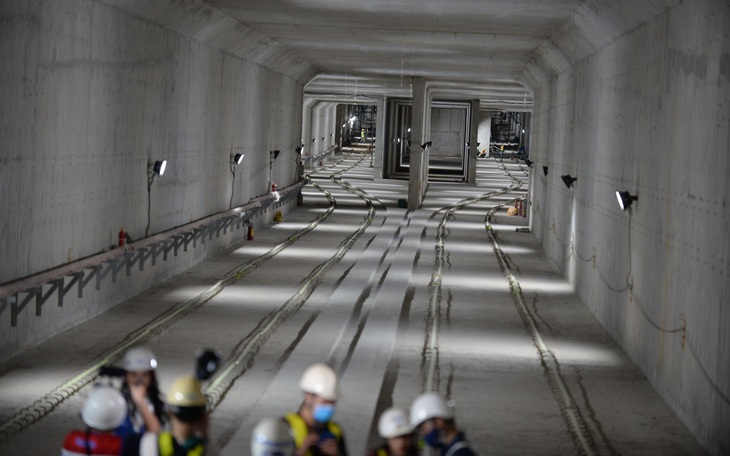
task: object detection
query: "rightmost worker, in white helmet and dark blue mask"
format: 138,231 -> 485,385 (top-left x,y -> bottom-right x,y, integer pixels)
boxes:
411,392 -> 474,456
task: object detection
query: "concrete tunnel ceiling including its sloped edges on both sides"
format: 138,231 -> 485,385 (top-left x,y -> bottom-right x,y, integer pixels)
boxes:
106,0 -> 682,110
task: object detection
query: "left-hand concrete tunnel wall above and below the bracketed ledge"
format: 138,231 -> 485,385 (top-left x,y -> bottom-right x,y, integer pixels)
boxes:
0,0 -> 303,356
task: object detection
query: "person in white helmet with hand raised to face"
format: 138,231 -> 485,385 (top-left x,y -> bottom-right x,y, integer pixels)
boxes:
116,347 -> 165,438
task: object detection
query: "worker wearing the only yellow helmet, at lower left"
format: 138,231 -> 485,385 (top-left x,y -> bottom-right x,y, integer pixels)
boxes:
122,375 -> 208,456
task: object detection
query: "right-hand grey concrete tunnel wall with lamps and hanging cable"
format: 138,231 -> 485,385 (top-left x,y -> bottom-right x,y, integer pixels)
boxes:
531,0 -> 730,454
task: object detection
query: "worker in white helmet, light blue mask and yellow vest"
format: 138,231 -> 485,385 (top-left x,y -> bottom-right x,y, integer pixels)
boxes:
284,364 -> 347,456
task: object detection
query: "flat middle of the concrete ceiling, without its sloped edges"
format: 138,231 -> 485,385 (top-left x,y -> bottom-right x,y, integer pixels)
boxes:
208,0 -> 584,106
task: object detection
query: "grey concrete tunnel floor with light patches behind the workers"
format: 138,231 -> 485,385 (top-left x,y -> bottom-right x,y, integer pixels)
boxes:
0,155 -> 705,455
